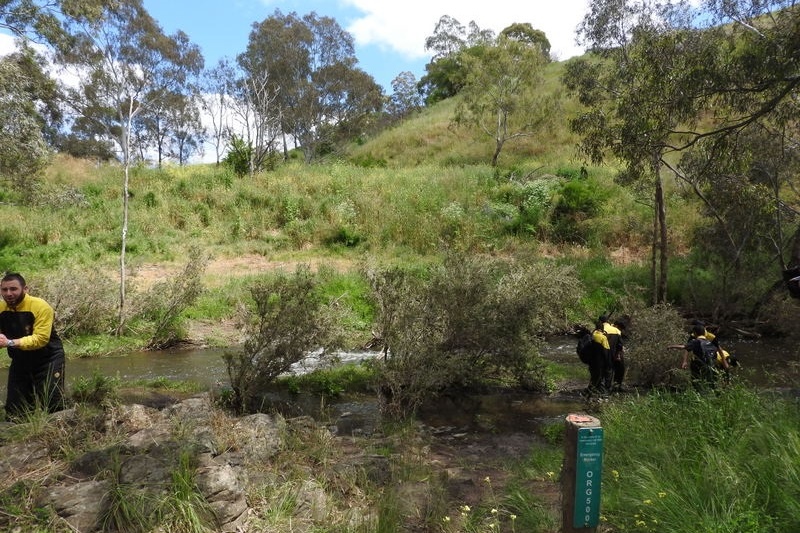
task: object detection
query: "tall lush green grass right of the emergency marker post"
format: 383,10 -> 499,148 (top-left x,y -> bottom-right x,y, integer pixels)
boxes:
602,386 -> 800,533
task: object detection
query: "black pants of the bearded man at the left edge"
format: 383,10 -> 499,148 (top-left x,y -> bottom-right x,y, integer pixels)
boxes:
6,355 -> 64,417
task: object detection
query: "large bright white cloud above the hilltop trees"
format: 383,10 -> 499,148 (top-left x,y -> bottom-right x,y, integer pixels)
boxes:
343,0 -> 589,59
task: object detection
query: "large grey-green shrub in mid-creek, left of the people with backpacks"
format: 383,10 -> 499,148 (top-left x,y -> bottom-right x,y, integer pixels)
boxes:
369,253 -> 580,417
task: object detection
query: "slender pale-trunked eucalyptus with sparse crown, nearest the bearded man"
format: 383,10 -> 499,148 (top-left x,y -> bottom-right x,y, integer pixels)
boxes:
57,0 -> 203,332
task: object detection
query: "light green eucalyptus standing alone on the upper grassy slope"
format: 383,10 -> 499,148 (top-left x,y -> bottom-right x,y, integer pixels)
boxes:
454,31 -> 558,167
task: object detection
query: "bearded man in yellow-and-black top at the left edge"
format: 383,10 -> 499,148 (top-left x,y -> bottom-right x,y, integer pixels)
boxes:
0,273 -> 65,418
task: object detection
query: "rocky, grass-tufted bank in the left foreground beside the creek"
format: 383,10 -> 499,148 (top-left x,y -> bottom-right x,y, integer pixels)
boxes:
0,386 -> 558,533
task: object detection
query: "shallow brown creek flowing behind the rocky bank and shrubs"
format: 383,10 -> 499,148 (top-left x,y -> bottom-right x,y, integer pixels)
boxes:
0,336 -> 800,433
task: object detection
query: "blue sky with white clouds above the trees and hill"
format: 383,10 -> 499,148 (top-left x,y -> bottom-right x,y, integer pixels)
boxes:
139,0 -> 588,93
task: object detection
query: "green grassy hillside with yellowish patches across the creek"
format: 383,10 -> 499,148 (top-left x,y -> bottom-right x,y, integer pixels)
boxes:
0,59 -> 724,354
